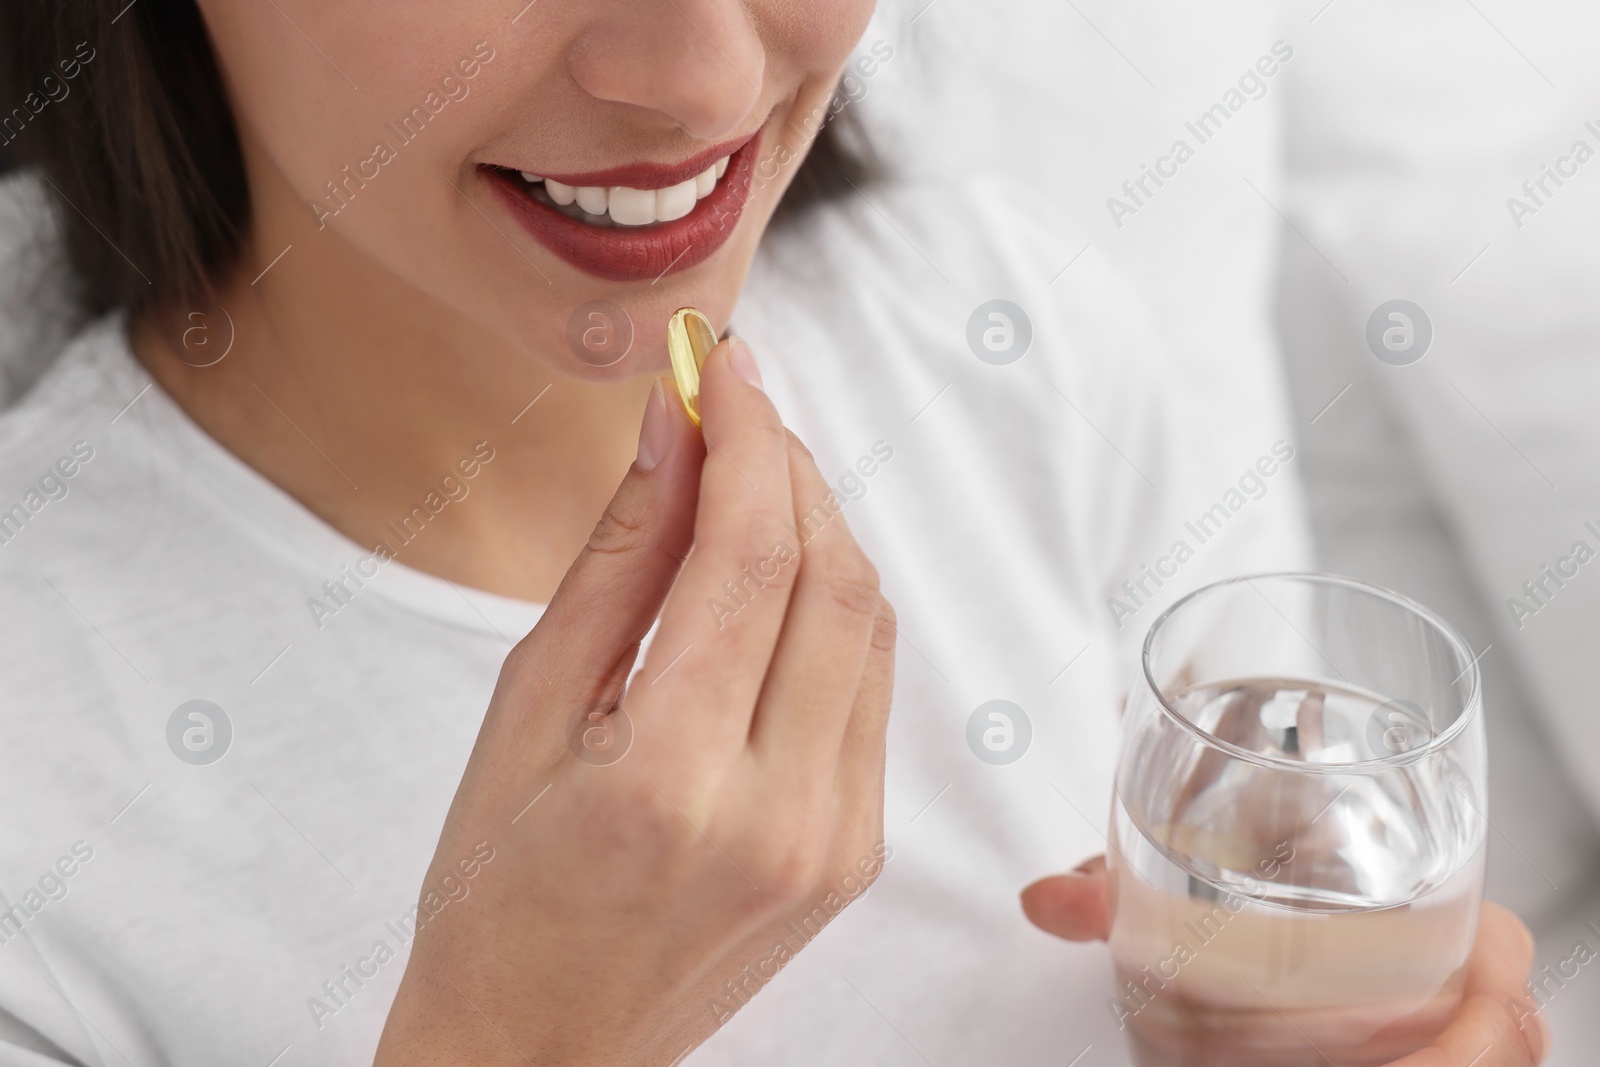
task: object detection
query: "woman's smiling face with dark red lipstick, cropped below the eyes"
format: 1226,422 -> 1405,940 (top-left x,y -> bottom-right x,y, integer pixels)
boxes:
200,0 -> 872,378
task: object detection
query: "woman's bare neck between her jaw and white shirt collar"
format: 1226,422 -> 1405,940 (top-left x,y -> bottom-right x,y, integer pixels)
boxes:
133,206 -> 650,601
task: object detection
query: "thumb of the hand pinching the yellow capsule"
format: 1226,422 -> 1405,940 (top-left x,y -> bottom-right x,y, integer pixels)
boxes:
506,382 -> 702,704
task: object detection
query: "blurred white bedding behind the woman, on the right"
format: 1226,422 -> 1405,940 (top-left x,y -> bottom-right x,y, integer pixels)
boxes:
856,0 -> 1600,1067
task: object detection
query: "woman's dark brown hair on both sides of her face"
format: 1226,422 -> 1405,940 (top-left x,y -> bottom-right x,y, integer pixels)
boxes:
0,0 -> 867,314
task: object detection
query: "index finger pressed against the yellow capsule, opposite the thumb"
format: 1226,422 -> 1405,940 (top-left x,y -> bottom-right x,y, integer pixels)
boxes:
629,338 -> 795,750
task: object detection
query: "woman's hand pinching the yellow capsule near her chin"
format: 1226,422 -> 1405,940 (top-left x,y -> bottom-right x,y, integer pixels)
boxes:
378,342 -> 894,1067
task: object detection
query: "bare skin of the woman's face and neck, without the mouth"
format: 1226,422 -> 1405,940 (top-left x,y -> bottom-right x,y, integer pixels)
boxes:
134,0 -> 870,601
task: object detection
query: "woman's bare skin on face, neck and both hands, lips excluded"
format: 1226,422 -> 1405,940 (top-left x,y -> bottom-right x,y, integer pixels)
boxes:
118,0 -> 1528,1067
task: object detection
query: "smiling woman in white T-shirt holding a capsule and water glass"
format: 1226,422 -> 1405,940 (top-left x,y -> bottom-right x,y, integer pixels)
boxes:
0,0 -> 1541,1067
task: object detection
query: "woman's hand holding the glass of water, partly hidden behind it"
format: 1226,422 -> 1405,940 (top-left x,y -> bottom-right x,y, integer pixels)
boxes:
1022,856 -> 1550,1067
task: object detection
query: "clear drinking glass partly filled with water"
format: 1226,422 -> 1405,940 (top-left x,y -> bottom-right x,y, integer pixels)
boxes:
1109,574 -> 1486,1067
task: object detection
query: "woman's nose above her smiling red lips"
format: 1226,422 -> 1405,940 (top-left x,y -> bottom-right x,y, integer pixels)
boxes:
568,0 -> 766,141
